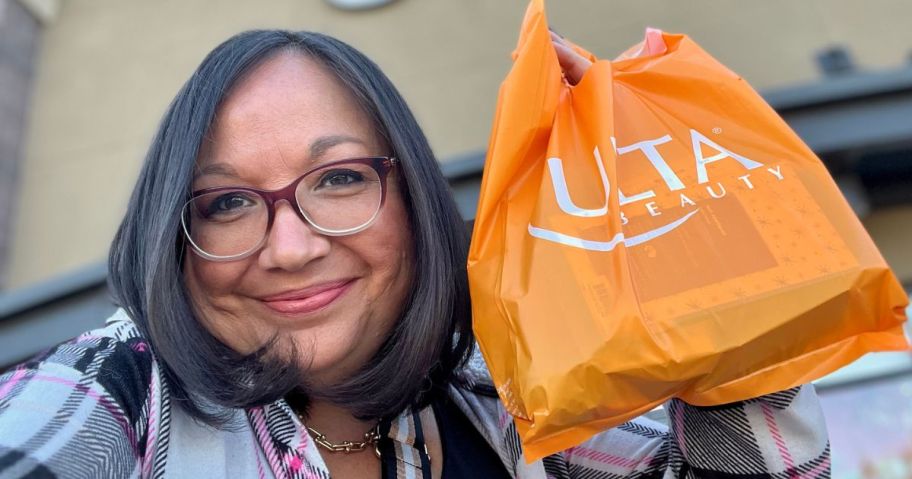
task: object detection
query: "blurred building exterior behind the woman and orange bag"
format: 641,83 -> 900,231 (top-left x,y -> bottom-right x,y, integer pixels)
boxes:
0,0 -> 912,477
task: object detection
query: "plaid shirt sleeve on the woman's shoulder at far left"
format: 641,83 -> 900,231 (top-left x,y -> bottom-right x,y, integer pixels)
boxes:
0,311 -> 154,477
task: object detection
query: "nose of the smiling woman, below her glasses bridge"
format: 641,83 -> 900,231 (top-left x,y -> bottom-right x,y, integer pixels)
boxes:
258,200 -> 331,271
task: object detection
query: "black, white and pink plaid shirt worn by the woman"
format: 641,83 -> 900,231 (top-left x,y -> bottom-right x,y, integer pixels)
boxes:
0,311 -> 830,479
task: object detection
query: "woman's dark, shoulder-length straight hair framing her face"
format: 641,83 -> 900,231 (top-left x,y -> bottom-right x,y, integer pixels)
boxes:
108,30 -> 474,425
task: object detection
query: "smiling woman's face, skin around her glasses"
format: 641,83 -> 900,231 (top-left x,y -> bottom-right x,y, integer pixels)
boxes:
184,53 -> 413,385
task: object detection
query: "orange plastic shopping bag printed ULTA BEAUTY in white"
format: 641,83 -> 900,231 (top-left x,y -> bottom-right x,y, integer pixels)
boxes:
468,0 -> 907,460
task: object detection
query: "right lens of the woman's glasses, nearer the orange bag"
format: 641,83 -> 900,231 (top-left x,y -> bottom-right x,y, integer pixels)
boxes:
295,162 -> 383,233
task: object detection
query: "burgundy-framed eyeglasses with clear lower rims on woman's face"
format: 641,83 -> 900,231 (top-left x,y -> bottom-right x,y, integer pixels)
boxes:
181,156 -> 398,261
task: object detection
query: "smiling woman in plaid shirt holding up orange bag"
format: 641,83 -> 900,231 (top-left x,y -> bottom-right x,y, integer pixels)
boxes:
0,31 -> 829,478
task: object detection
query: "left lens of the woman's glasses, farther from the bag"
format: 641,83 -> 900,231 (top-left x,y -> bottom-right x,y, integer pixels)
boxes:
183,190 -> 269,257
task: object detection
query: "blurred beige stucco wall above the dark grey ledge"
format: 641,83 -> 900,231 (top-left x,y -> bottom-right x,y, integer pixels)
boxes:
8,0 -> 912,287
